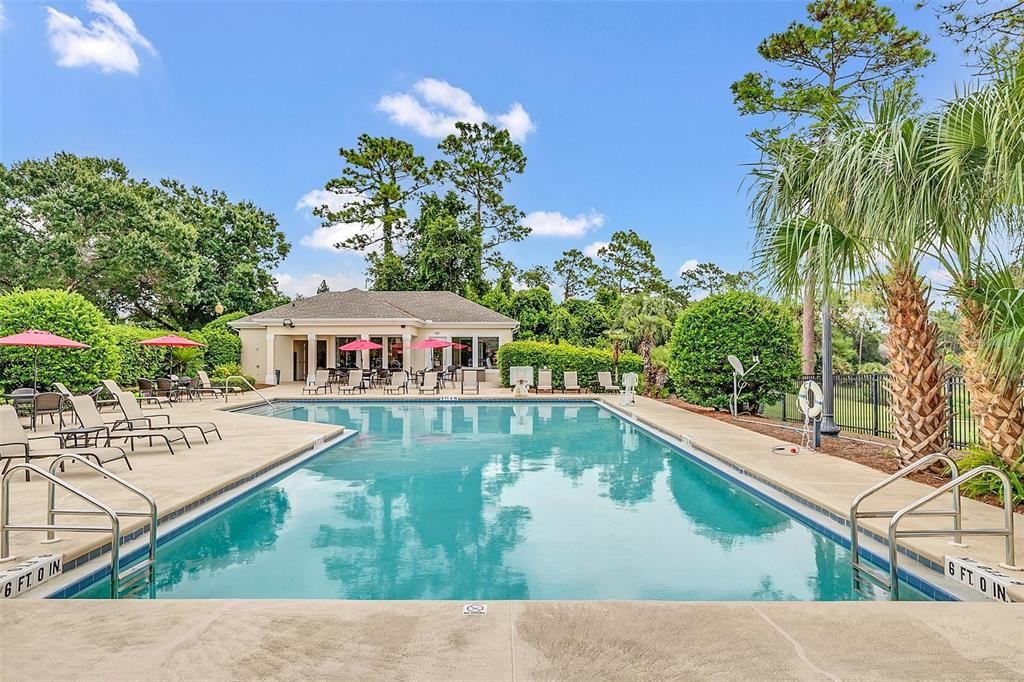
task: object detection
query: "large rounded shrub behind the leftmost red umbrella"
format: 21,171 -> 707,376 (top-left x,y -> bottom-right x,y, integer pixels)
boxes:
0,289 -> 119,392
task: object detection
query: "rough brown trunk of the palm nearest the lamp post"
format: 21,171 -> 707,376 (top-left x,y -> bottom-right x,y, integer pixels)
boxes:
887,267 -> 949,464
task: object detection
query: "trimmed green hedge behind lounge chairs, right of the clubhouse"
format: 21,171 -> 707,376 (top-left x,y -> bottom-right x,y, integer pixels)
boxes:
498,341 -> 643,388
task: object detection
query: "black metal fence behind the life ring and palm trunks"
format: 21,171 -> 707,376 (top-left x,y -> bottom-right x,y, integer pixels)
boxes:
763,374 -> 977,447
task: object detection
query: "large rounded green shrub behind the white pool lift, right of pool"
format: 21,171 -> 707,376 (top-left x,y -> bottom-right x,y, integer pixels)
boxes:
669,291 -> 800,411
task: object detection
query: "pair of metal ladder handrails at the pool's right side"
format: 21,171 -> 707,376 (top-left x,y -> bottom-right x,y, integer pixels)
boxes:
850,453 -> 1024,601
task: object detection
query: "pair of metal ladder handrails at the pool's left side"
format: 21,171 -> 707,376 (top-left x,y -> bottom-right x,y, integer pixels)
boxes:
0,455 -> 158,599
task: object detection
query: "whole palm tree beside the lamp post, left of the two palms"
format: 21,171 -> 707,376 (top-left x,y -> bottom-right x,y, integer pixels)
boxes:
752,92 -> 948,463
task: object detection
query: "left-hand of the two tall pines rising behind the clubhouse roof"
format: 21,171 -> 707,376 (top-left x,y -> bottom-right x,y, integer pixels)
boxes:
313,133 -> 440,289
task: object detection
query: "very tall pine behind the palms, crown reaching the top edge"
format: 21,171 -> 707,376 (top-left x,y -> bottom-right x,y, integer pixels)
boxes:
732,0 -> 933,374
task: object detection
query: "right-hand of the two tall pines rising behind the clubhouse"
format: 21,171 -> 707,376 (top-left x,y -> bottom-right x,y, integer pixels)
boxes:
437,121 -> 529,269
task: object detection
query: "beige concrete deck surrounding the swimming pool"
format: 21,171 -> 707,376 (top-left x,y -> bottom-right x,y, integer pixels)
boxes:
0,384 -> 1024,680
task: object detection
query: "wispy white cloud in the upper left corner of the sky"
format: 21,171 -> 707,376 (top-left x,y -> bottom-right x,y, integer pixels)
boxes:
46,0 -> 157,74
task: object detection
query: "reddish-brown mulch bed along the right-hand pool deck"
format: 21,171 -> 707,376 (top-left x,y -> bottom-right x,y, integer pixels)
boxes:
662,397 -> 1024,513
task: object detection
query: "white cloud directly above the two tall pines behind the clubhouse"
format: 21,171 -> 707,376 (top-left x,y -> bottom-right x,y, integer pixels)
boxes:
377,78 -> 536,142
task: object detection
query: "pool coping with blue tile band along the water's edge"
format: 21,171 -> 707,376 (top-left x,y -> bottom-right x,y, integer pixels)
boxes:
39,395 -> 976,601
